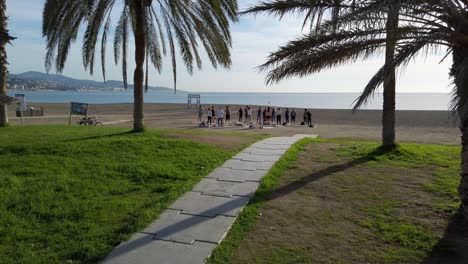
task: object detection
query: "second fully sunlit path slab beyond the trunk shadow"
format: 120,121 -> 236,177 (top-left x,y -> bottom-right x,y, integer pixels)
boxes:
206,167 -> 265,182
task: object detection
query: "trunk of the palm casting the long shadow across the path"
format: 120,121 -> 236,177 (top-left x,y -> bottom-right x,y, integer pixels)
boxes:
382,0 -> 401,147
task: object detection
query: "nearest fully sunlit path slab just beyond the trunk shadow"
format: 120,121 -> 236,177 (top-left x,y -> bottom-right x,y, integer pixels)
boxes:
193,178 -> 260,197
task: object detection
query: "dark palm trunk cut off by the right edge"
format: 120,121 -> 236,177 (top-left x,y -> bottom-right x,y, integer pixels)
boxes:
451,48 -> 468,223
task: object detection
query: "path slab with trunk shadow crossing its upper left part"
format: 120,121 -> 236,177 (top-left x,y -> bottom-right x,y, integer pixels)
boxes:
142,210 -> 236,244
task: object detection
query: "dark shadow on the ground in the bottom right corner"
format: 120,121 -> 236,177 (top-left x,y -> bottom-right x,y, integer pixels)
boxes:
421,213 -> 468,264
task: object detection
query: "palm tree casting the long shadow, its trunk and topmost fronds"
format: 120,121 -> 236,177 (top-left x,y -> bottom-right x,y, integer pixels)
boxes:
243,0 -> 401,147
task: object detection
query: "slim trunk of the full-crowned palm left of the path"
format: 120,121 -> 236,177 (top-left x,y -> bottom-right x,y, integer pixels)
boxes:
133,0 -> 146,132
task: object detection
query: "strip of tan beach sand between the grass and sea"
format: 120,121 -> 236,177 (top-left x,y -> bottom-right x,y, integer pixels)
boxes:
9,103 -> 460,145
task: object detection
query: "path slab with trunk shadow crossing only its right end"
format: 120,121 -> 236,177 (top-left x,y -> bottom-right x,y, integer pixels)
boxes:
169,192 -> 249,217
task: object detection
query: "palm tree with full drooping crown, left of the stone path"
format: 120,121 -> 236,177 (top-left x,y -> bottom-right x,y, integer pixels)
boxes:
43,0 -> 237,131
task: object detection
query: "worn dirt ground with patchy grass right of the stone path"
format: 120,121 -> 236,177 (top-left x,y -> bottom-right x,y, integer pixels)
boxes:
232,143 -> 468,263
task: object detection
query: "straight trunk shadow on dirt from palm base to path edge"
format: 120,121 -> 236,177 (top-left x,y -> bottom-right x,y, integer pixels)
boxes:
252,146 -> 396,202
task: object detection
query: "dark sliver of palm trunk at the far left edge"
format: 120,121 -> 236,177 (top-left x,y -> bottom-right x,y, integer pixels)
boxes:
0,0 -> 8,127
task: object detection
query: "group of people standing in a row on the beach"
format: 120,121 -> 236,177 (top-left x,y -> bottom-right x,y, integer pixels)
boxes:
198,105 -> 312,127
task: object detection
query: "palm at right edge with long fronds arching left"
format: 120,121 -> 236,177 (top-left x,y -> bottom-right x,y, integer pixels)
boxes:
243,0 -> 468,224
